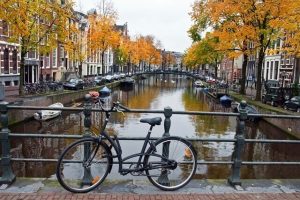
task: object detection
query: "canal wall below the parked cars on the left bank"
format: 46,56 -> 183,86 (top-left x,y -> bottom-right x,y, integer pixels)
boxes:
8,81 -> 120,125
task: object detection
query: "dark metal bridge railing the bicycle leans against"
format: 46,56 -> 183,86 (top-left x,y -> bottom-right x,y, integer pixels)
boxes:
0,95 -> 300,185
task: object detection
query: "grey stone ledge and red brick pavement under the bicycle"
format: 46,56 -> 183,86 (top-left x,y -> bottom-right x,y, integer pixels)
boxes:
0,178 -> 300,200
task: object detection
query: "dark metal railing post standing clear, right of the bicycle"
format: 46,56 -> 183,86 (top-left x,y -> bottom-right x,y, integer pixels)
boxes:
228,101 -> 247,186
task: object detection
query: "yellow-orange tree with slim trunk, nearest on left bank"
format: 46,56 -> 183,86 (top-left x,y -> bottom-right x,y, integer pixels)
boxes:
0,0 -> 72,95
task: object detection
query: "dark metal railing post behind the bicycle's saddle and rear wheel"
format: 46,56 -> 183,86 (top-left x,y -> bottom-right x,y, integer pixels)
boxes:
158,107 -> 172,186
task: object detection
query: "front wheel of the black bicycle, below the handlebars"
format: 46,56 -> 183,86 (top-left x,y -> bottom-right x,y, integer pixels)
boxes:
56,138 -> 112,193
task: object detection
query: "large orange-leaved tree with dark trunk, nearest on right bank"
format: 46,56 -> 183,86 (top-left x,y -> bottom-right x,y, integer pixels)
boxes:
193,0 -> 299,100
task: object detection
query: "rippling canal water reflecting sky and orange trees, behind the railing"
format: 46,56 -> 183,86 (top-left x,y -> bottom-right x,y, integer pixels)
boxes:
5,75 -> 300,179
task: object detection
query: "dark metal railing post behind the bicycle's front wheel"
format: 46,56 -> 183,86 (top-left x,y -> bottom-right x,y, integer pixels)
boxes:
82,94 -> 93,185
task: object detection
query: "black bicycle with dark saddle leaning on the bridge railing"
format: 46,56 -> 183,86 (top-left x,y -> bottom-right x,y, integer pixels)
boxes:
56,102 -> 197,193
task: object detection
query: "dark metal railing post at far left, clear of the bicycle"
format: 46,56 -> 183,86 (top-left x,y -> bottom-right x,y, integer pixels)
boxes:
0,101 -> 16,184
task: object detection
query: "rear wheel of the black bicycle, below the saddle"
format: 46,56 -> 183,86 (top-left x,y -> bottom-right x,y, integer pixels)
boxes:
144,136 -> 197,191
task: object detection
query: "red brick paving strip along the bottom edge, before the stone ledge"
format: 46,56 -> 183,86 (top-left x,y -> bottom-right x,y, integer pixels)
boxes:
0,193 -> 300,200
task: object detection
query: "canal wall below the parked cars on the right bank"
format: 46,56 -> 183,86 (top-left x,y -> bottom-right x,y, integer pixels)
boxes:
230,92 -> 300,139
